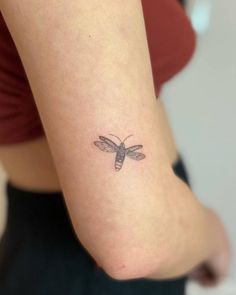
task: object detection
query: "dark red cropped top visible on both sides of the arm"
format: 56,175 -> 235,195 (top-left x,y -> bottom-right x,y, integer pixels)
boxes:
0,0 -> 195,144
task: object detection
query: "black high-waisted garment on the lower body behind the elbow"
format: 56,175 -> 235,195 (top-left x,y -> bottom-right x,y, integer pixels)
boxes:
0,159 -> 188,295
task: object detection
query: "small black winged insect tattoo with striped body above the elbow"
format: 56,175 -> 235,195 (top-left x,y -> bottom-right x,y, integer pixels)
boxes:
94,134 -> 145,171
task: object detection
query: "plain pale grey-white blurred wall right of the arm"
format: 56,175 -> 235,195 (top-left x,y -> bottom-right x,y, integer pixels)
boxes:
162,0 -> 236,295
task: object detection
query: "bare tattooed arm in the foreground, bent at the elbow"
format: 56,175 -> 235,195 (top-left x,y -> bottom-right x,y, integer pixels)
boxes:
0,0 -> 227,279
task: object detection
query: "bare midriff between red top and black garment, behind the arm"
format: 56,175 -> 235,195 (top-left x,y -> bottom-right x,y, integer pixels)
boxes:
0,99 -> 177,191
